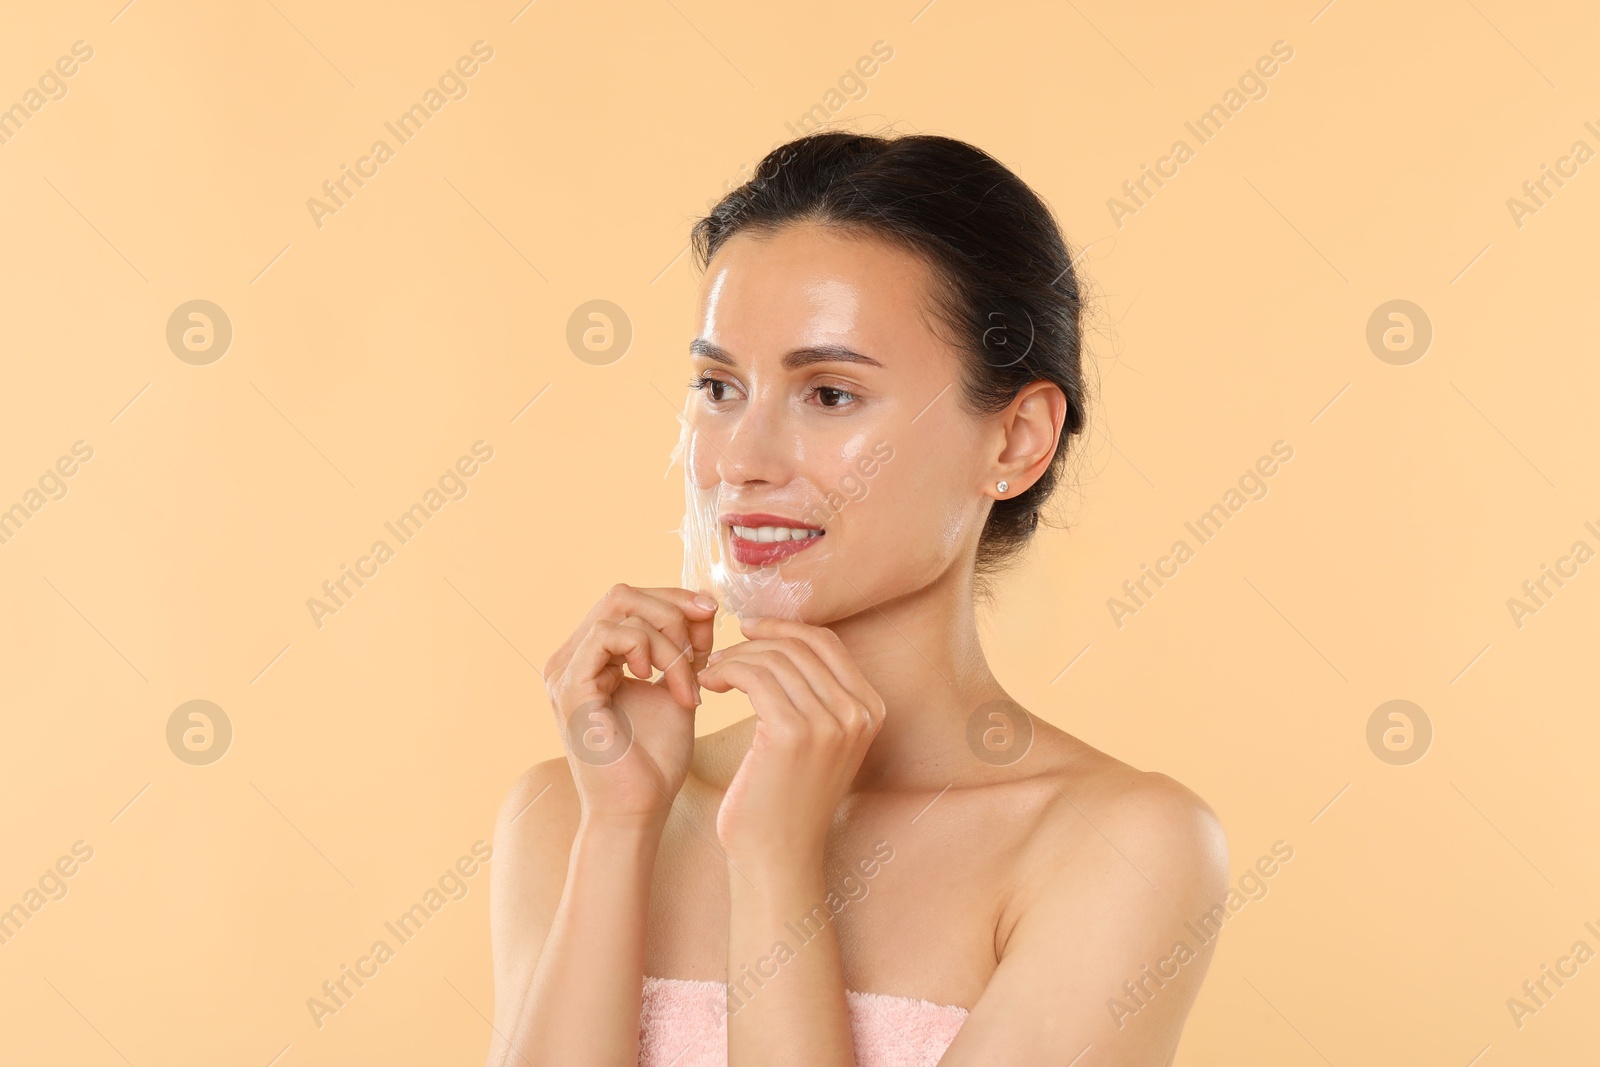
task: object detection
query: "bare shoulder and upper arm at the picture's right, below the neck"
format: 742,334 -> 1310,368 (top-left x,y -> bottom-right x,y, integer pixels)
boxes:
939,774 -> 1227,1067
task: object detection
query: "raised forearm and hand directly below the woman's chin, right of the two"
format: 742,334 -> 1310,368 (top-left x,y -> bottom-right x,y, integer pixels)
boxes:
699,619 -> 885,1067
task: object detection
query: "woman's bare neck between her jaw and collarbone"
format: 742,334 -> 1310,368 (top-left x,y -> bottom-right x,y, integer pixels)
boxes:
829,566 -> 1005,790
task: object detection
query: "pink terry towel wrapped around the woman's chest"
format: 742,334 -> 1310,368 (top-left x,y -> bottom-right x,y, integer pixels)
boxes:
638,976 -> 966,1067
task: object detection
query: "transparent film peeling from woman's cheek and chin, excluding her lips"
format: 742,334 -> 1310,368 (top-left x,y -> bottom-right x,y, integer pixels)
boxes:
667,390 -> 830,621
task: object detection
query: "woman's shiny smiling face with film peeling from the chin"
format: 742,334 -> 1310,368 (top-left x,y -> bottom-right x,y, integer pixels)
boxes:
685,224 -> 1002,625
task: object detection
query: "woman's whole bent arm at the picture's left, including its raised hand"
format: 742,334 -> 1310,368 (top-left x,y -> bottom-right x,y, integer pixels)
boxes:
486,584 -> 717,1067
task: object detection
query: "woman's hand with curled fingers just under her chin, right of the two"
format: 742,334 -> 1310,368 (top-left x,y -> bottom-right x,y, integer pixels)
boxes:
699,619 -> 885,869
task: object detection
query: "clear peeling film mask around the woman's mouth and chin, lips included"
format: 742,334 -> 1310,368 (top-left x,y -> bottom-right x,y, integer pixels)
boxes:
672,404 -> 830,621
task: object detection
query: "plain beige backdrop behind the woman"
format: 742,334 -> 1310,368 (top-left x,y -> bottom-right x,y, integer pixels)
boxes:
0,0 -> 1600,1067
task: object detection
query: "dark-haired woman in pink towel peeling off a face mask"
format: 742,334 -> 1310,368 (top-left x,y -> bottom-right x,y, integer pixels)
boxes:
488,133 -> 1227,1067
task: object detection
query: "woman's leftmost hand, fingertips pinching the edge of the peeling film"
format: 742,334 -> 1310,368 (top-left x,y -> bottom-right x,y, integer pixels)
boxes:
544,584 -> 717,819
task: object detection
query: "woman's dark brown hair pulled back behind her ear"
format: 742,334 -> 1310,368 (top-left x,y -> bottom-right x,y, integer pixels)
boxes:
691,131 -> 1085,573
